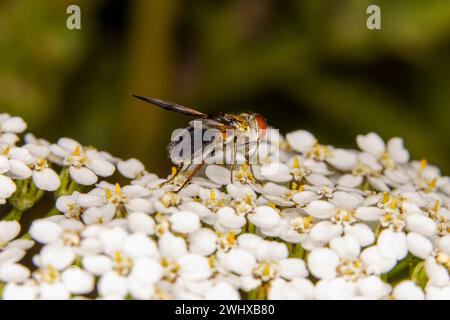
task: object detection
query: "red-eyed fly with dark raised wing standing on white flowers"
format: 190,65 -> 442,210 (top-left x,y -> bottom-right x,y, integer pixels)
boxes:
133,95 -> 267,192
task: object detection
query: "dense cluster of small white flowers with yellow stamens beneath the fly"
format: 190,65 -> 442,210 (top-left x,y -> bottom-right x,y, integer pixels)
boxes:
0,114 -> 450,300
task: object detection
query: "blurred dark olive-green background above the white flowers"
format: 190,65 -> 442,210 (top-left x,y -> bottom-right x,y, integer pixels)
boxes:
0,0 -> 450,174
